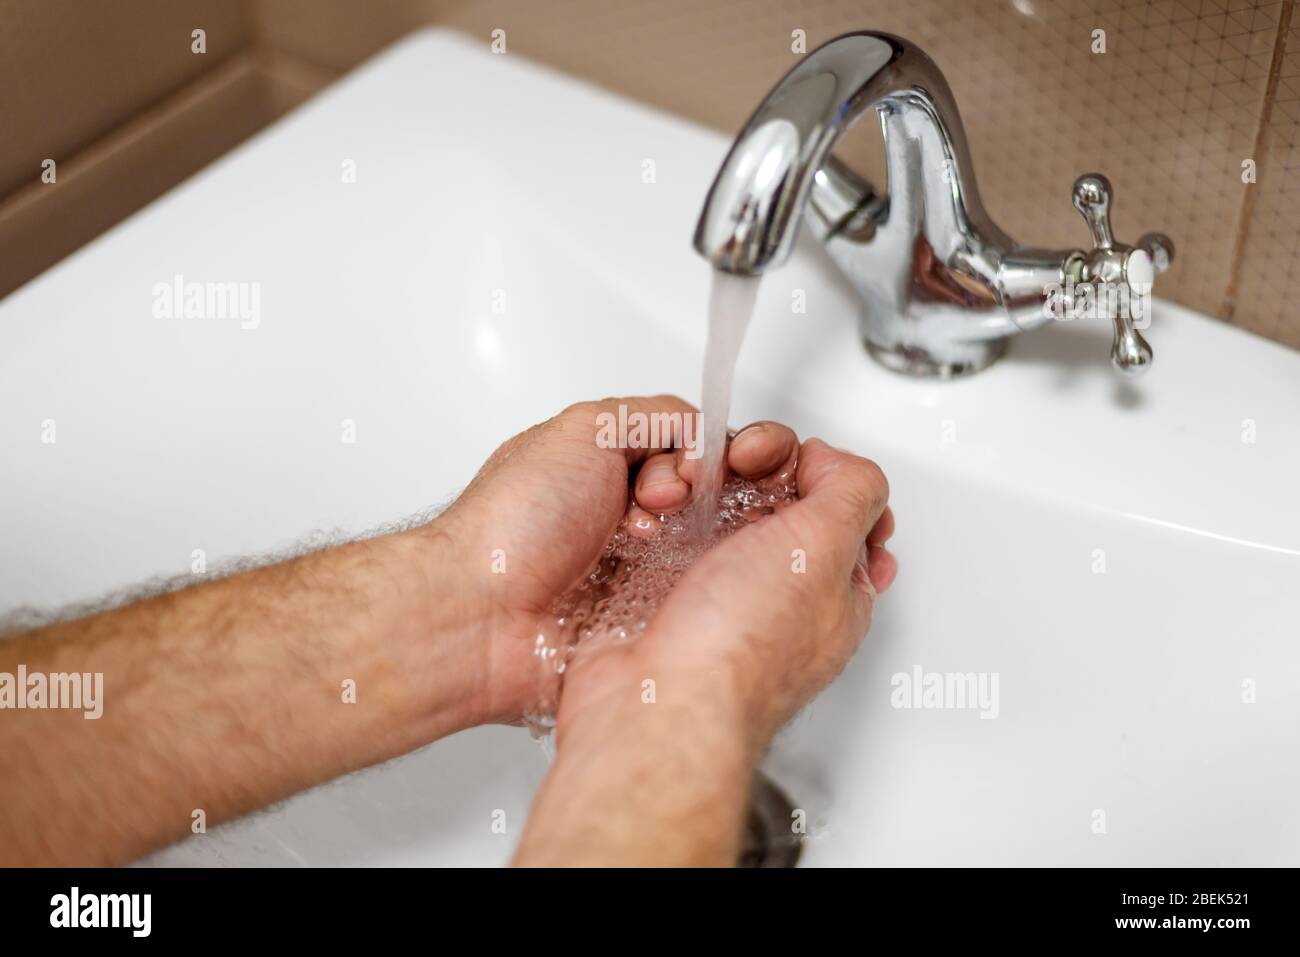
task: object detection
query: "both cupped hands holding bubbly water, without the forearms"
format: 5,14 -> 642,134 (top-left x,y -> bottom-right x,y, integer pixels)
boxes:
439,397 -> 897,749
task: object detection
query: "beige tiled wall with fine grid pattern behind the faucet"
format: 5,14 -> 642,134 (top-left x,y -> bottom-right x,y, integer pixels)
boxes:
0,0 -> 1300,347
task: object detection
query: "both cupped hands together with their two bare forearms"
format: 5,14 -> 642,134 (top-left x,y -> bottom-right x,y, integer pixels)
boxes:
0,397 -> 896,865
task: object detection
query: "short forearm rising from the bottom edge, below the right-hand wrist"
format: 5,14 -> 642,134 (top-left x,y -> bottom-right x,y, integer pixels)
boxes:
515,657 -> 759,867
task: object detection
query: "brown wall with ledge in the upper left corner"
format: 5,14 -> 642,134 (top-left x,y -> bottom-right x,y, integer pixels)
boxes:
0,0 -> 334,296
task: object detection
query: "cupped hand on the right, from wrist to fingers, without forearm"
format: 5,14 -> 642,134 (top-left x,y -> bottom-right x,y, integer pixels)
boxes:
556,423 -> 897,752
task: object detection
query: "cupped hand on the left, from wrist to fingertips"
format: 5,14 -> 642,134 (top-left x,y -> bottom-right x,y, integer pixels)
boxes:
434,395 -> 816,723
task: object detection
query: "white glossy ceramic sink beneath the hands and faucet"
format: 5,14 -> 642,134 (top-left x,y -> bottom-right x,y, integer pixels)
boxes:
0,31 -> 1300,865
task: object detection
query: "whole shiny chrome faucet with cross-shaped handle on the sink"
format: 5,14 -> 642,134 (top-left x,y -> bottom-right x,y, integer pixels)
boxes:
696,33 -> 1174,378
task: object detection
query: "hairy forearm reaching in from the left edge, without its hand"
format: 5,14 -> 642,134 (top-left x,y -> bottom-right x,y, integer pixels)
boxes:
0,523 -> 485,865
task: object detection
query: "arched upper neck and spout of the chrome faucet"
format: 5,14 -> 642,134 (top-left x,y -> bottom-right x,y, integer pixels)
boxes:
696,33 -> 1011,276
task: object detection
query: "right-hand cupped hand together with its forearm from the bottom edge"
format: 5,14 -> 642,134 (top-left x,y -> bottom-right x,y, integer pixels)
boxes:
517,424 -> 897,865
